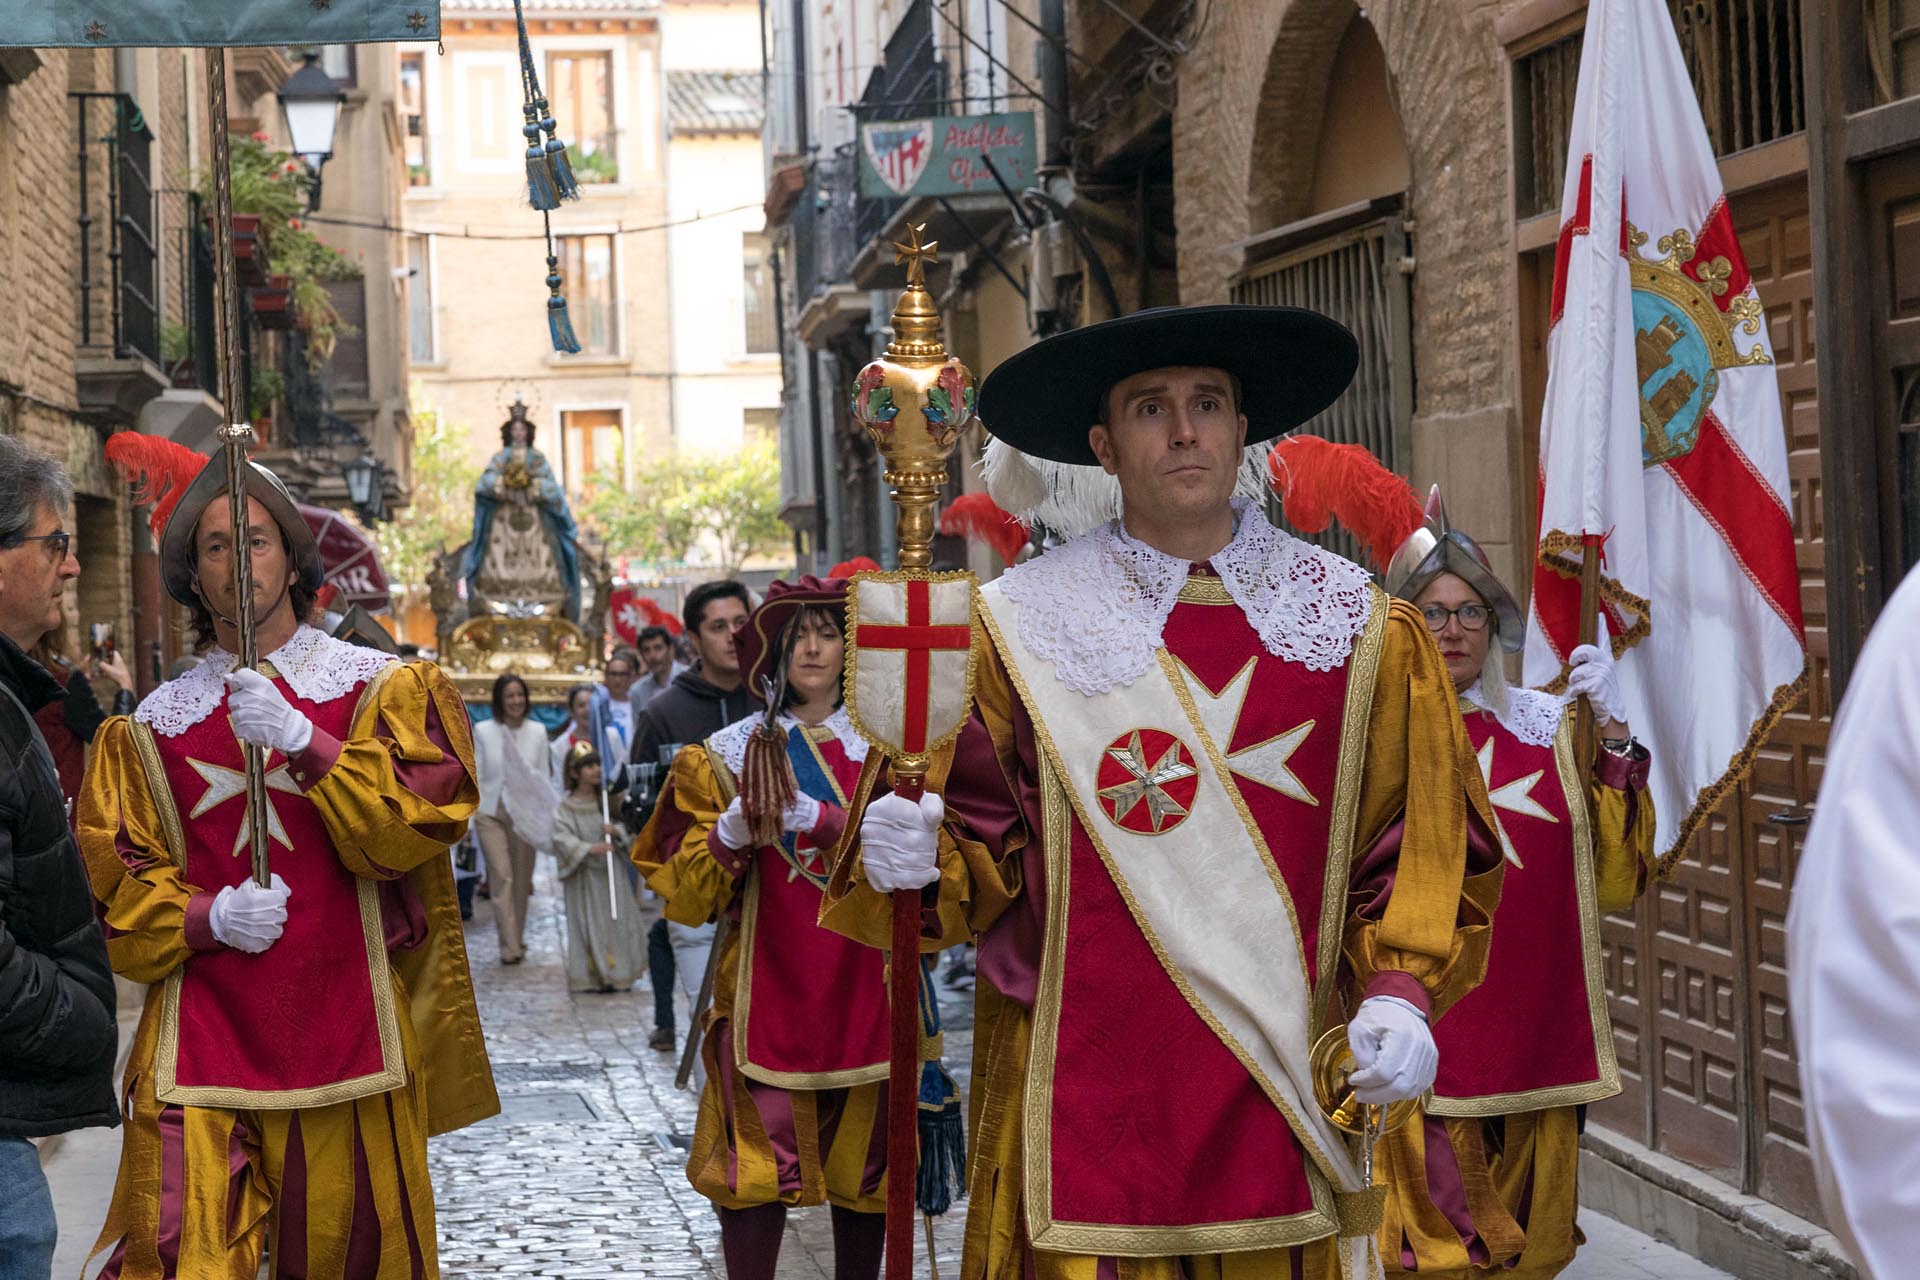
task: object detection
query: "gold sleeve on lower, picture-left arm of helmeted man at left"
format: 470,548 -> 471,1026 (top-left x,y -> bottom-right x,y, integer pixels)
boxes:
75,716 -> 200,983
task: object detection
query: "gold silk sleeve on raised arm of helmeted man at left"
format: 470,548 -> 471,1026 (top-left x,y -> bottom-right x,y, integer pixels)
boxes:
307,662 -> 480,881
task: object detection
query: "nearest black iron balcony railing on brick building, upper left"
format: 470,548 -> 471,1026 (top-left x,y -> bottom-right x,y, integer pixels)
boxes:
67,94 -> 159,365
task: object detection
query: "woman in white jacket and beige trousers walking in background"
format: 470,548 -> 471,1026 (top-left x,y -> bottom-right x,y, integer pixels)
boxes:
474,672 -> 559,965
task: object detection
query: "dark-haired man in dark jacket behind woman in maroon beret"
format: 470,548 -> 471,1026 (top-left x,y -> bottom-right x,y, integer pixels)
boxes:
632,581 -> 756,1052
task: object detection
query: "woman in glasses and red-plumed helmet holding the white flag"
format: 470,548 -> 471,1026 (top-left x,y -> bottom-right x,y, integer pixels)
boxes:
1273,438 -> 1653,1280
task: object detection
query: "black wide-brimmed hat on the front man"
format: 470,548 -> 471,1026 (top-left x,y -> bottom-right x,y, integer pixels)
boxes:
979,305 -> 1359,466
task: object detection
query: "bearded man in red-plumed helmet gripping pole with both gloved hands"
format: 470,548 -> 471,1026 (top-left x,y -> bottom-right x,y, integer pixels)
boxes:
79,441 -> 499,1280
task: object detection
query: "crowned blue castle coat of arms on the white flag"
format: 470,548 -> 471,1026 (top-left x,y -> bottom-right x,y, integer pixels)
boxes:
1626,223 -> 1772,466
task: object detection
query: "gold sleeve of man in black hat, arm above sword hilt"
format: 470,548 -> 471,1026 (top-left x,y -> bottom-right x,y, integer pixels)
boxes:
1346,601 -> 1505,1017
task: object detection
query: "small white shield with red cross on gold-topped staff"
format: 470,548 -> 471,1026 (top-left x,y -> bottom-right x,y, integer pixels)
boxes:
847,572 -> 975,756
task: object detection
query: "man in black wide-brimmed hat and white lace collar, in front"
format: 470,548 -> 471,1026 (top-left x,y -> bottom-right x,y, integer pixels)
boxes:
824,307 -> 1500,1280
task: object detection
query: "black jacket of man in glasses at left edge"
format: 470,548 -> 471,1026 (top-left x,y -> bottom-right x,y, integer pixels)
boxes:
0,635 -> 119,1138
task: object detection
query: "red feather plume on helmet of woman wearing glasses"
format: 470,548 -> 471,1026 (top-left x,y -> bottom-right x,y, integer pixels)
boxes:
1267,436 -> 1427,570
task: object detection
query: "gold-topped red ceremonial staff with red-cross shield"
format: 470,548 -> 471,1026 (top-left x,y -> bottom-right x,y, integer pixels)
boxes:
847,226 -> 977,1280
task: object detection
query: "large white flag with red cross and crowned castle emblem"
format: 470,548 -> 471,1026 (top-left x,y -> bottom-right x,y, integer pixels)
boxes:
1526,0 -> 1807,871
